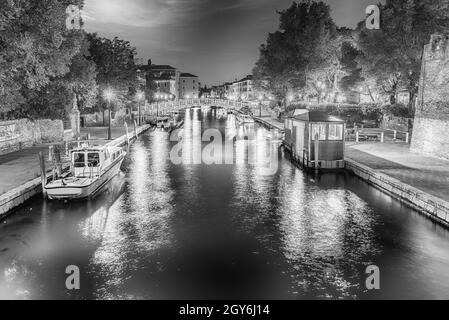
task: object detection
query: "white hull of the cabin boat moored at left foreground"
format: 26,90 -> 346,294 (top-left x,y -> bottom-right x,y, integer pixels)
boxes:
45,155 -> 125,200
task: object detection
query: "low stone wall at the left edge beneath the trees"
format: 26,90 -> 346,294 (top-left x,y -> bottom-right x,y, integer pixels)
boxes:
0,119 -> 64,154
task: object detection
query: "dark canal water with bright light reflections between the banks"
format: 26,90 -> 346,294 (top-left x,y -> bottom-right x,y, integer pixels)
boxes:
0,110 -> 449,299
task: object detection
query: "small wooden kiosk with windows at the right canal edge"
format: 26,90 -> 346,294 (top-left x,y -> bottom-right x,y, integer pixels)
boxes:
284,110 -> 346,170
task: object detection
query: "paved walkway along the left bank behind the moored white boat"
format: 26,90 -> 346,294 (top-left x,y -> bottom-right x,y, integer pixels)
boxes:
0,126 -> 133,195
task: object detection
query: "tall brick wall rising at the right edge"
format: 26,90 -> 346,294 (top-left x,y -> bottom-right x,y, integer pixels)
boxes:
411,34 -> 449,160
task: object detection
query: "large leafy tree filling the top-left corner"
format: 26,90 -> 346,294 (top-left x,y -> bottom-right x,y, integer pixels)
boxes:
0,0 -> 84,116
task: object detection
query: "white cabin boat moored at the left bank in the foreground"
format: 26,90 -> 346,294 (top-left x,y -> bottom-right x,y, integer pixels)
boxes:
45,145 -> 126,200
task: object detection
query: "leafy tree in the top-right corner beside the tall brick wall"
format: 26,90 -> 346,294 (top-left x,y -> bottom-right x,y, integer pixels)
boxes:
358,0 -> 449,108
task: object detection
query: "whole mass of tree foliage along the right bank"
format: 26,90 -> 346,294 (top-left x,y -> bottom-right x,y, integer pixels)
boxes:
254,0 -> 449,106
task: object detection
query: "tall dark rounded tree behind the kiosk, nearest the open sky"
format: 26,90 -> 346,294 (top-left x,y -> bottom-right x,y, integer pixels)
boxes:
253,0 -> 345,105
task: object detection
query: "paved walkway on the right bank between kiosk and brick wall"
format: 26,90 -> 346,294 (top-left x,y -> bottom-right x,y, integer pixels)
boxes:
346,142 -> 449,201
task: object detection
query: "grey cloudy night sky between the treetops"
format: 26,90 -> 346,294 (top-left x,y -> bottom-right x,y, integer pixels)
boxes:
85,0 -> 379,85
